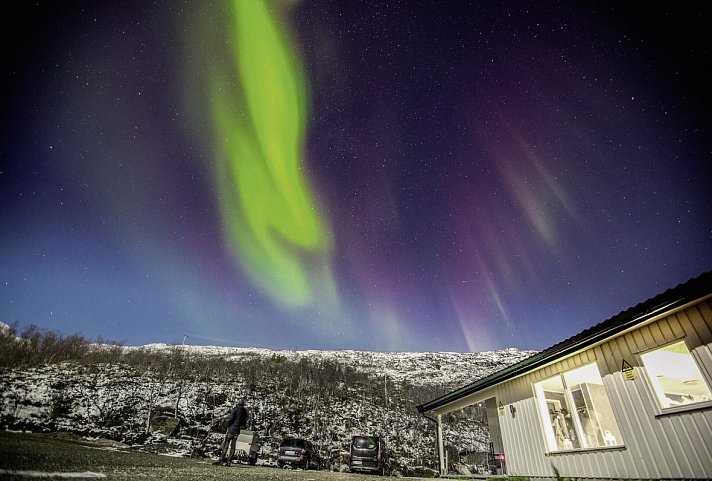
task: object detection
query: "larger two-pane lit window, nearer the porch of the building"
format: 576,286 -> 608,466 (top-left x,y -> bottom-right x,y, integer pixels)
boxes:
534,364 -> 623,451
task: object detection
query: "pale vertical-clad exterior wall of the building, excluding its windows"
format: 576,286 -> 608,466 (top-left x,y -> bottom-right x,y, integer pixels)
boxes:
441,299 -> 712,479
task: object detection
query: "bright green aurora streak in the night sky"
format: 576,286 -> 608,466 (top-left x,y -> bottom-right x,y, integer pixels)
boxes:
210,0 -> 334,307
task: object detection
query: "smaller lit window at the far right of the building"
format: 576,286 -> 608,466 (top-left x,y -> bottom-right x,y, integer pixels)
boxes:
640,341 -> 712,408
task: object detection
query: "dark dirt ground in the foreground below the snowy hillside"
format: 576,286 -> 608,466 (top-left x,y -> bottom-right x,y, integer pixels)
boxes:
0,431 -> 434,481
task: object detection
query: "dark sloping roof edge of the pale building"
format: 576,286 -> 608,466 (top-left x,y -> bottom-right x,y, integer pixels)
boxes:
418,271 -> 712,413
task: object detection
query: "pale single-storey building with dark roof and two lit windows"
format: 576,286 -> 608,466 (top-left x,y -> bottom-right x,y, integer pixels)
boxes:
418,271 -> 712,480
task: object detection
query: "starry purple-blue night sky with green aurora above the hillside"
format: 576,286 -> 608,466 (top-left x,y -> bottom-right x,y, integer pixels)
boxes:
0,0 -> 712,352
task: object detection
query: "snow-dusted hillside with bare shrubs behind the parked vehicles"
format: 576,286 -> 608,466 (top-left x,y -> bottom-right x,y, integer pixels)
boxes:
0,330 -> 532,473
